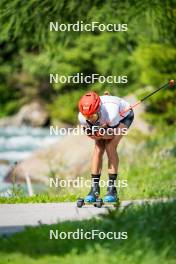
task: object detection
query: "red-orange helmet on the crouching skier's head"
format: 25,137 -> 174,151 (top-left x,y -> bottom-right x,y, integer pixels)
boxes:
79,92 -> 100,116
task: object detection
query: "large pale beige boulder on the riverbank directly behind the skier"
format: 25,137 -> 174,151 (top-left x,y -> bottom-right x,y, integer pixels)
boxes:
5,135 -> 94,184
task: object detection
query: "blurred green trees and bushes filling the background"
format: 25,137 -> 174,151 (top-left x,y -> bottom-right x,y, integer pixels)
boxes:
0,0 -> 176,124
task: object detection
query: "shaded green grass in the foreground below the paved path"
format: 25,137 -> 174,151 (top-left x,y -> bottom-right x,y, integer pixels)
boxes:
0,202 -> 176,264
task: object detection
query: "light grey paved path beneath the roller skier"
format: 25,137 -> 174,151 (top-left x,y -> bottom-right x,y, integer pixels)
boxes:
0,198 -> 173,235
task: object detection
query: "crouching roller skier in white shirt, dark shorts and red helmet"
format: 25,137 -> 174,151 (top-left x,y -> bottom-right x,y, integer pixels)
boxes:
78,92 -> 134,203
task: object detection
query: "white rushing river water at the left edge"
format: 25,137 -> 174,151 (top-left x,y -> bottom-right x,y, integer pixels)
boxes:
0,126 -> 58,194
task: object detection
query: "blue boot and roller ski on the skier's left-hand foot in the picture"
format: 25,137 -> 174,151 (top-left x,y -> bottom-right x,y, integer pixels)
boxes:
77,184 -> 103,208
